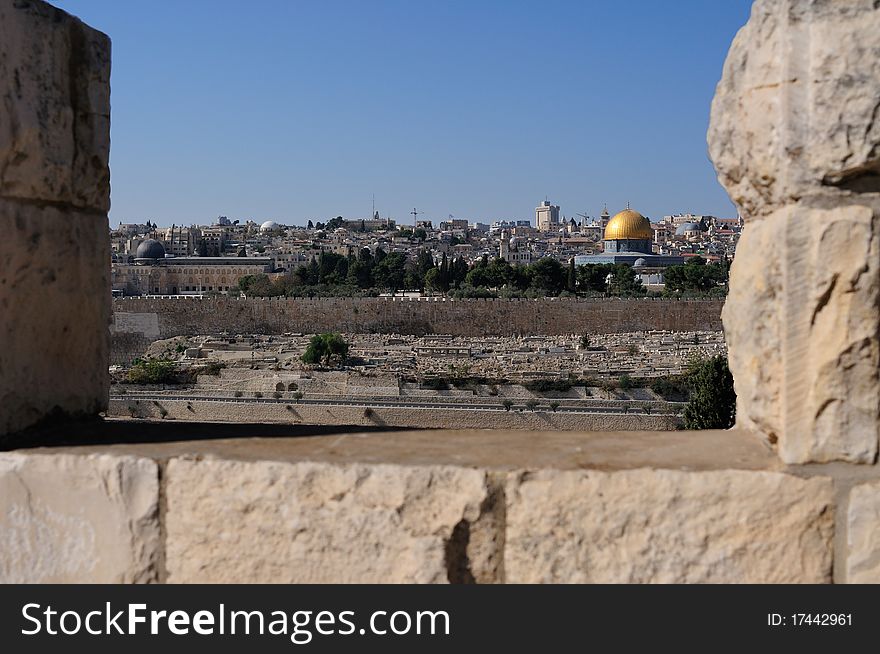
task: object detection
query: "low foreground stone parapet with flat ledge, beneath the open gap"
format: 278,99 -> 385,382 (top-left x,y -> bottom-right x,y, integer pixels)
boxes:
0,426 -> 868,583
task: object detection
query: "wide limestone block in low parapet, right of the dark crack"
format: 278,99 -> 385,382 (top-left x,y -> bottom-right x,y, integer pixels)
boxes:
504,469 -> 833,583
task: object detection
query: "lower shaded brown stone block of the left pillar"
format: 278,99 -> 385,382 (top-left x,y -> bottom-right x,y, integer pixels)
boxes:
0,199 -> 110,437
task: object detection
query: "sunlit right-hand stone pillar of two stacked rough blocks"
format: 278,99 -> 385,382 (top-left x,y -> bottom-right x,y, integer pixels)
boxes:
708,0 -> 880,464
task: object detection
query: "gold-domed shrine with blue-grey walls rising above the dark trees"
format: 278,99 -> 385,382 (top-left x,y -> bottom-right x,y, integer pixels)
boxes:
574,206 -> 684,268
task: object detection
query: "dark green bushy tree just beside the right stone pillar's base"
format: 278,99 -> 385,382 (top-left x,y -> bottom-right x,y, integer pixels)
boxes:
684,354 -> 736,429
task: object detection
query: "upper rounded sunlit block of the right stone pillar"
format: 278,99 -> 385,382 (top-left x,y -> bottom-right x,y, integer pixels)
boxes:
708,0 -> 880,220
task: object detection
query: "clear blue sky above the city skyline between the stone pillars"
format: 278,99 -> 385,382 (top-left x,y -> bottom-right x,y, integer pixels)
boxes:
55,0 -> 751,225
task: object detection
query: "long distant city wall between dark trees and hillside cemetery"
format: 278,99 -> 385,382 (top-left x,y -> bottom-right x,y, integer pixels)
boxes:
112,298 -> 723,338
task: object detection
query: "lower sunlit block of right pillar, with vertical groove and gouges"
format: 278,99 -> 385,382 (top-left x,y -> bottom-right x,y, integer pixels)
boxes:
723,205 -> 880,463
